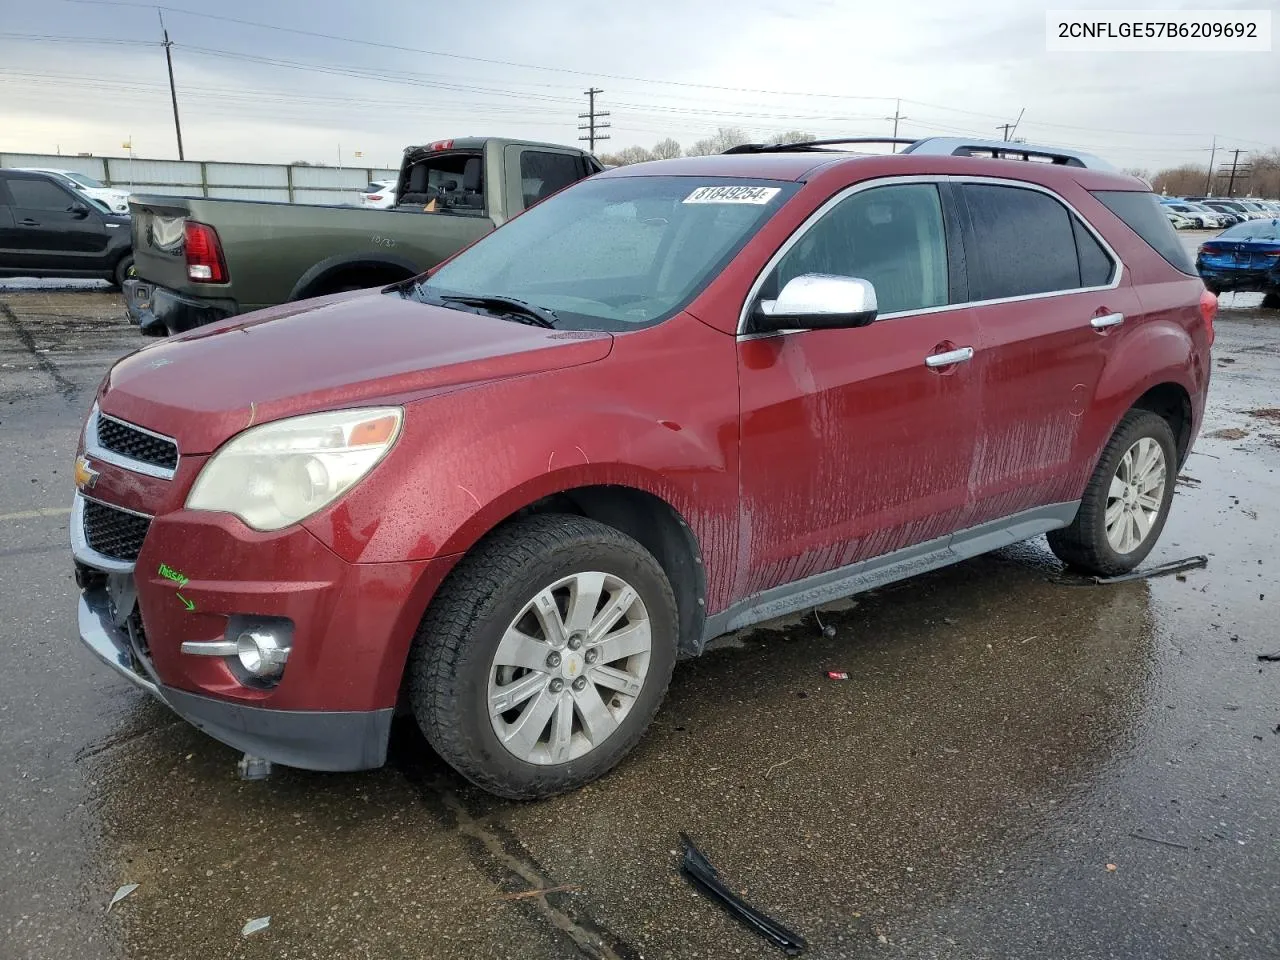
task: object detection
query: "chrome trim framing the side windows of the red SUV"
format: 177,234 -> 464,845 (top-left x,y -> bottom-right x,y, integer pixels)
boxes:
735,174 -> 1125,339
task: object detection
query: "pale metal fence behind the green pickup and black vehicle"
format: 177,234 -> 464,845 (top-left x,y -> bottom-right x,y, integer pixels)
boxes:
0,154 -> 398,205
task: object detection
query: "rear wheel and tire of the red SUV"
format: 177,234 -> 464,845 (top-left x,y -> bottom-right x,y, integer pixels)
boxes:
1048,410 -> 1178,576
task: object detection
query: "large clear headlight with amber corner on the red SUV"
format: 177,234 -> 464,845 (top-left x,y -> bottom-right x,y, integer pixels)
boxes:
187,407 -> 404,530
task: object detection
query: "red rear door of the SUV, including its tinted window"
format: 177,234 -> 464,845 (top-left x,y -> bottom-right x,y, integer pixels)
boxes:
952,178 -> 1140,524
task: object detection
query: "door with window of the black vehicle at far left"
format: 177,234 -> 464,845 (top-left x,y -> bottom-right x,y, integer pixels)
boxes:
5,173 -> 109,273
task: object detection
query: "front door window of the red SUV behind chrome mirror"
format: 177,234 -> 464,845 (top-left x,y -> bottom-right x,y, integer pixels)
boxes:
762,183 -> 948,314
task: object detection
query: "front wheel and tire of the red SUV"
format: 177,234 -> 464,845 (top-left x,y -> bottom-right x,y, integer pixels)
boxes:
407,513 -> 678,800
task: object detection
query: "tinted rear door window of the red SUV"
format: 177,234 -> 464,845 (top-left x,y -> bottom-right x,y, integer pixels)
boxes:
961,183 -> 1080,300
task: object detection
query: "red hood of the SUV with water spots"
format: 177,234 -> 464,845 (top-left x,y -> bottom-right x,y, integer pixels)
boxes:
99,291 -> 613,453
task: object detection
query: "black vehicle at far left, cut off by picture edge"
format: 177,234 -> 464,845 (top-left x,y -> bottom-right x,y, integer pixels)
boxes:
0,169 -> 133,287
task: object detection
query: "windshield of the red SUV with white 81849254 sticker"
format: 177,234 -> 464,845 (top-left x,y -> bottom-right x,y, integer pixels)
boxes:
404,177 -> 800,332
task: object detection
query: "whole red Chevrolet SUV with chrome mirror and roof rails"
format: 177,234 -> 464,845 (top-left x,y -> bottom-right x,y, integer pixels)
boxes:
70,138 -> 1216,797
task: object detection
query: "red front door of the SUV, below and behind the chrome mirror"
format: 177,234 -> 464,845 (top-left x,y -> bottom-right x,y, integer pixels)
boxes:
735,182 -> 980,599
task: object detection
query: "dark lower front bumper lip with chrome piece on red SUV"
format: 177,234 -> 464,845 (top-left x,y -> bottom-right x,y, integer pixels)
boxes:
78,586 -> 394,771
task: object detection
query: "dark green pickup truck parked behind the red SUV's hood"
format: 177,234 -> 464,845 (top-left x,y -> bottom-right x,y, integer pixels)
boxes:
124,137 -> 604,337
